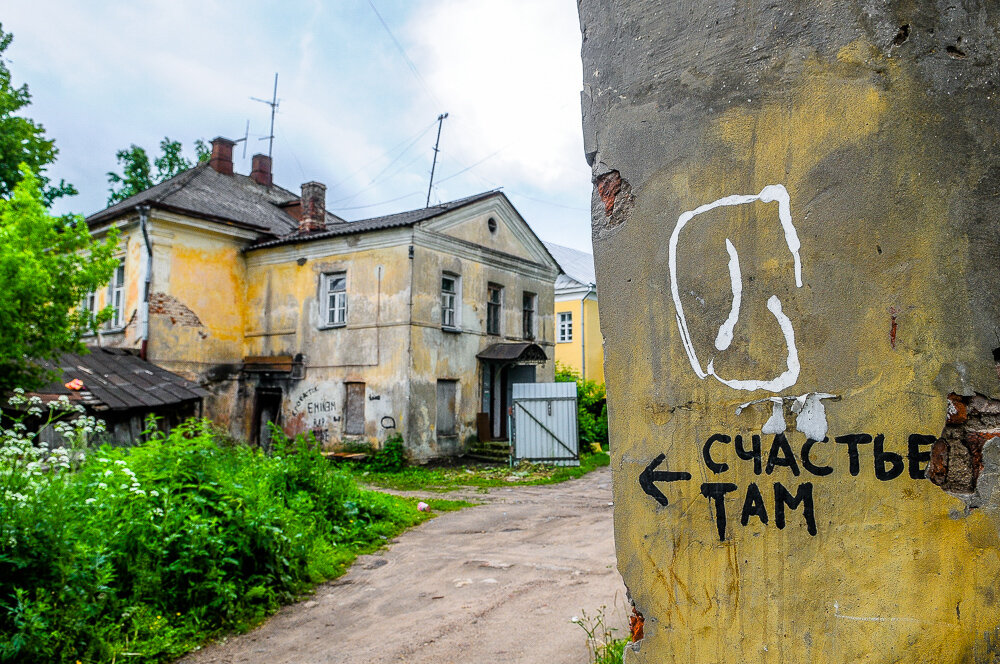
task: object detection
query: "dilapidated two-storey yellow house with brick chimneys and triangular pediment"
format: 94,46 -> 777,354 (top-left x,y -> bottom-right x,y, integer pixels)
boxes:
85,138 -> 559,459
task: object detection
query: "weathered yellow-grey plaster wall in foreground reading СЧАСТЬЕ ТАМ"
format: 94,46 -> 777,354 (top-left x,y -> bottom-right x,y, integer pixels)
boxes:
580,0 -> 1000,664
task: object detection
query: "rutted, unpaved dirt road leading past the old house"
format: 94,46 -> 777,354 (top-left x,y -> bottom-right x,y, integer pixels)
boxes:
181,468 -> 627,664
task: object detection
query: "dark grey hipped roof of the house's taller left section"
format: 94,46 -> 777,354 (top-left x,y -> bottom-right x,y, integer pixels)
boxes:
87,164 -> 343,235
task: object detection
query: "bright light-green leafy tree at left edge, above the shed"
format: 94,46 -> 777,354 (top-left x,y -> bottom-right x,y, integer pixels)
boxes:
0,164 -> 118,389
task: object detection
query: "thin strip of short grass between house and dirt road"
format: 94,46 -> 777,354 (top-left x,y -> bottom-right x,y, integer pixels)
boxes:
354,452 -> 611,492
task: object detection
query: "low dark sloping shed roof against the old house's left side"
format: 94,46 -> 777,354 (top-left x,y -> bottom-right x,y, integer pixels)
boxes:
37,346 -> 208,410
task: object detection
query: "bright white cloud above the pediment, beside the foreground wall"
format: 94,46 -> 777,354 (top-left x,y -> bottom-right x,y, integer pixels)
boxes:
406,0 -> 587,189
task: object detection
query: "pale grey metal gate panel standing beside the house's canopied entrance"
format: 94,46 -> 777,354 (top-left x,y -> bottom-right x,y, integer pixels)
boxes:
511,382 -> 580,466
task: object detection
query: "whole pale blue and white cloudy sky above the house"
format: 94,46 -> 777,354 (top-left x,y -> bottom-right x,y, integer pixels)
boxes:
0,0 -> 590,251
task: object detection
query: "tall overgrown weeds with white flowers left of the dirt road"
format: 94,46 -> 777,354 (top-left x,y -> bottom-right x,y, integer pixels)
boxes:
0,421 -> 467,664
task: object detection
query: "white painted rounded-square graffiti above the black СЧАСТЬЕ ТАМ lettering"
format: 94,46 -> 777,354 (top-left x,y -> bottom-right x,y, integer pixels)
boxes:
669,184 -> 802,393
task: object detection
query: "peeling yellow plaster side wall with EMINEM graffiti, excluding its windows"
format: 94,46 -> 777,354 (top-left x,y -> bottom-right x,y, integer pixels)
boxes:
246,236 -> 410,443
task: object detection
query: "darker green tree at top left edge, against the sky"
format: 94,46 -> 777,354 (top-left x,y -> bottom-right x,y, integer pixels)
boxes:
0,24 -> 77,207
